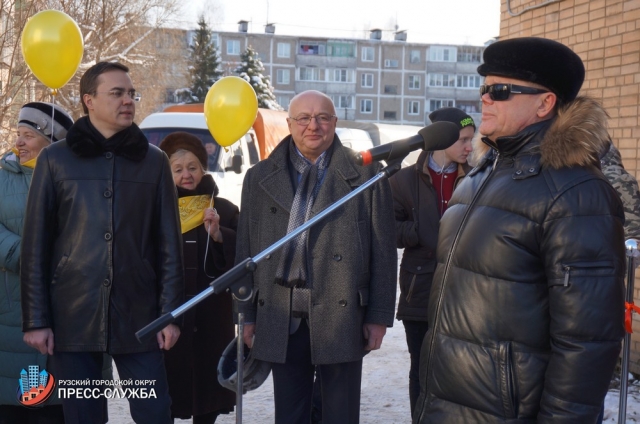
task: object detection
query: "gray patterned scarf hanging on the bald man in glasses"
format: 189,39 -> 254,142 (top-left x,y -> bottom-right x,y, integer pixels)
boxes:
275,139 -> 331,287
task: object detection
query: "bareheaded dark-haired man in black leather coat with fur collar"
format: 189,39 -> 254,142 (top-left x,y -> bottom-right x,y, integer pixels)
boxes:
16,62 -> 183,424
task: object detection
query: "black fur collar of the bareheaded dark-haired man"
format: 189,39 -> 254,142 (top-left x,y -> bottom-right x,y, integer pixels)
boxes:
67,116 -> 149,162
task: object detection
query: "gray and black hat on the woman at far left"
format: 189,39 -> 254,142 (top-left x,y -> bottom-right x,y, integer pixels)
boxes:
18,102 -> 73,142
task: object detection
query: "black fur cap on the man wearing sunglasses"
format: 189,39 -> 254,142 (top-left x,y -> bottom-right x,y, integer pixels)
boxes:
478,37 -> 584,103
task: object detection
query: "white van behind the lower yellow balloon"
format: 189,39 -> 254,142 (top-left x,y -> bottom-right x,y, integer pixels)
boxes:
139,112 -> 260,207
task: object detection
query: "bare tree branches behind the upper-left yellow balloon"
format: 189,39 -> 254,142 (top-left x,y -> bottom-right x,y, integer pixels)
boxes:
0,0 -> 187,152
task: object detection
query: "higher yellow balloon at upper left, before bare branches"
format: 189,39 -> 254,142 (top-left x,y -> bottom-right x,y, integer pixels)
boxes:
21,10 -> 84,89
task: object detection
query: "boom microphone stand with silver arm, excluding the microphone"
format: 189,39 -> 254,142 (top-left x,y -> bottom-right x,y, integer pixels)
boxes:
136,158 -> 406,424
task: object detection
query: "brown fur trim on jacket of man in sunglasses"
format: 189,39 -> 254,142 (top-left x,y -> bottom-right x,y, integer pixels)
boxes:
474,96 -> 610,169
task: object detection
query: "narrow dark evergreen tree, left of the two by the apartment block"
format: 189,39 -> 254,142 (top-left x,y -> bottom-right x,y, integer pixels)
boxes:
189,15 -> 224,102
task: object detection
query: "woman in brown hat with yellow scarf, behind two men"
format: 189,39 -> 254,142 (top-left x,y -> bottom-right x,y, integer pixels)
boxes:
159,132 -> 239,424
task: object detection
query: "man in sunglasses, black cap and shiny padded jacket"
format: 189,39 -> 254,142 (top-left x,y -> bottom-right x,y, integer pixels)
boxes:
414,37 -> 625,424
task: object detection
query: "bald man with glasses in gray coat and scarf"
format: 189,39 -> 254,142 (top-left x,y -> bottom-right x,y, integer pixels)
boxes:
236,91 -> 397,424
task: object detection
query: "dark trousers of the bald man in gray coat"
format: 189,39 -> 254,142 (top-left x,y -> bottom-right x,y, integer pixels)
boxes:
271,320 -> 362,424
